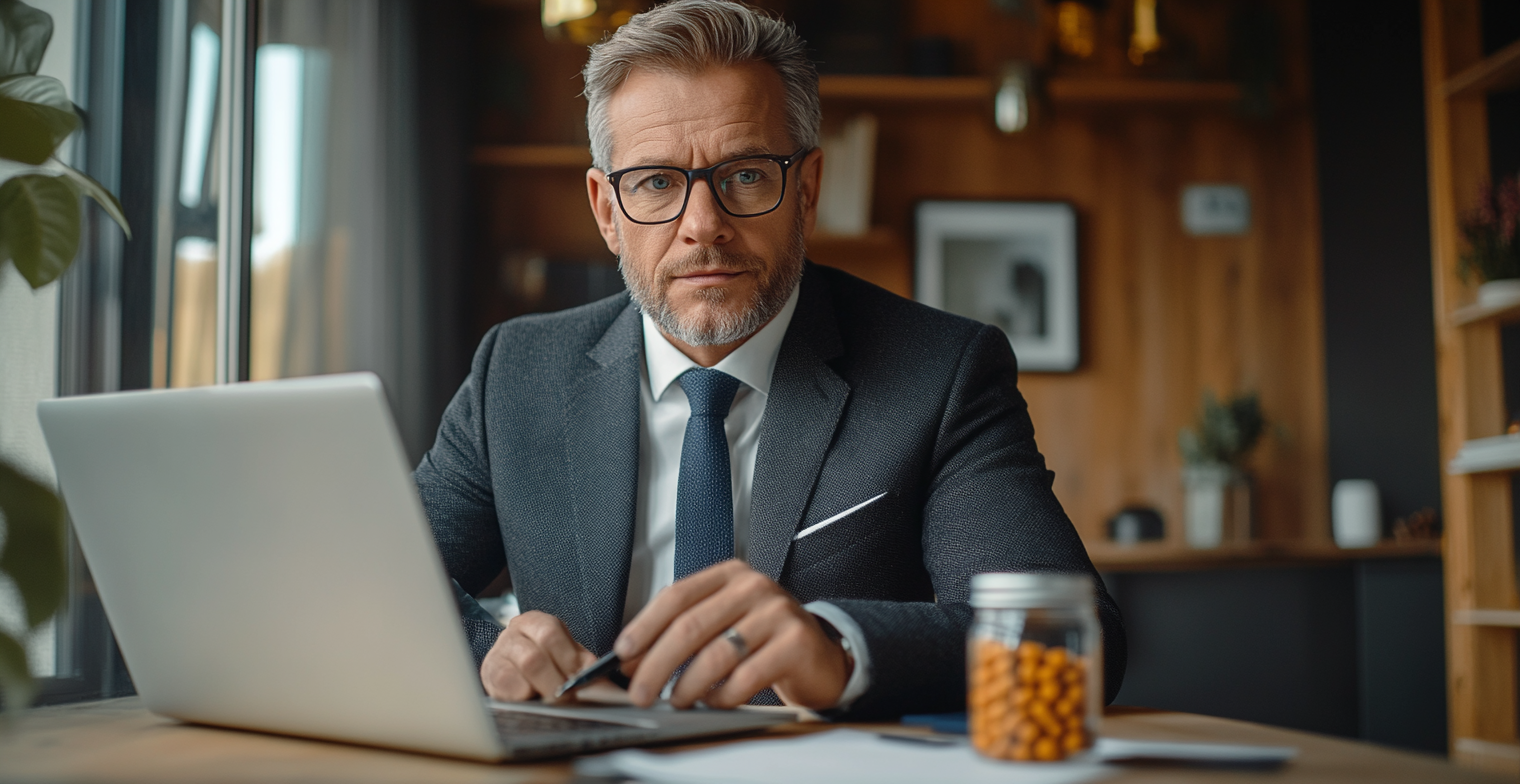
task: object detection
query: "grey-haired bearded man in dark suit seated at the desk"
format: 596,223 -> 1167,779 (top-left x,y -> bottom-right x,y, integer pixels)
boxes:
416,0 -> 1125,717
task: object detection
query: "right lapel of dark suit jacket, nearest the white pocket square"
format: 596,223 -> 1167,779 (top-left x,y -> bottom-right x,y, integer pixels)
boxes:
748,264 -> 850,580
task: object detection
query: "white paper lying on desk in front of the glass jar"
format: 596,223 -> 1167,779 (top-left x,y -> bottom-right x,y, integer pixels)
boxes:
576,729 -> 1119,784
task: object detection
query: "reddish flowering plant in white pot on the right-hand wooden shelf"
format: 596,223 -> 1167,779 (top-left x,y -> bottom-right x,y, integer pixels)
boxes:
1458,175 -> 1520,305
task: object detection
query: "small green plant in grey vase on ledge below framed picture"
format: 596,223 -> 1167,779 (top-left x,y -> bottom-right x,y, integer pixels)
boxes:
1178,392 -> 1266,548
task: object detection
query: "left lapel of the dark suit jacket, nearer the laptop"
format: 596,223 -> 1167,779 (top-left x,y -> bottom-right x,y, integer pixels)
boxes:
565,304 -> 641,652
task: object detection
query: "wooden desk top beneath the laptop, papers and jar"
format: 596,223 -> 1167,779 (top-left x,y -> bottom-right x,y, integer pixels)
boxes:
0,697 -> 1509,784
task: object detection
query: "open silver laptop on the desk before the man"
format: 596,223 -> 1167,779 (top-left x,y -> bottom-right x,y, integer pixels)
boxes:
38,374 -> 795,761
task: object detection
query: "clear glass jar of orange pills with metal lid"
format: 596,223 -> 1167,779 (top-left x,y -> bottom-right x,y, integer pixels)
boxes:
967,573 -> 1104,761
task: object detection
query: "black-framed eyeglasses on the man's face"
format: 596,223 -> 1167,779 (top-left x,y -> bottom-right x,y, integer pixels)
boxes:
606,147 -> 813,226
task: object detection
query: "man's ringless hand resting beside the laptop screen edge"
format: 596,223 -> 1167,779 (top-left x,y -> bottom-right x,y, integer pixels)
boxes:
480,611 -> 596,702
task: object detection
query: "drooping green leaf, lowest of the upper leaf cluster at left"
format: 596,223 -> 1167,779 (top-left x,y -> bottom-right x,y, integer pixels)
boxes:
0,175 -> 79,289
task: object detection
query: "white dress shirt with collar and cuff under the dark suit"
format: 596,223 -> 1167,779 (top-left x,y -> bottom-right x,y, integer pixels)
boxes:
623,289 -> 871,707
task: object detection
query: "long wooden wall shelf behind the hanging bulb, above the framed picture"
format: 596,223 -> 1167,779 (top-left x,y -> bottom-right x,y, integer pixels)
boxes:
818,76 -> 1240,106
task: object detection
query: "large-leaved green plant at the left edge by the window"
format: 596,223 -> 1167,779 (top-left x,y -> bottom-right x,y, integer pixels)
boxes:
0,0 -> 131,711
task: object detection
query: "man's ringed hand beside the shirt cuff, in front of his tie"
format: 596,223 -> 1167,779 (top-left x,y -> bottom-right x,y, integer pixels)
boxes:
617,561 -> 850,708
